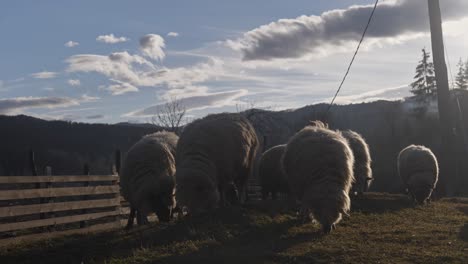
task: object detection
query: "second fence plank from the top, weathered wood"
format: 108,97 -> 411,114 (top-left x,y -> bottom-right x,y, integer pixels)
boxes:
0,185 -> 119,201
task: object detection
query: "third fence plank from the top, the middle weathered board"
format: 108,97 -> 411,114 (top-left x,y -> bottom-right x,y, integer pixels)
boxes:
0,198 -> 120,217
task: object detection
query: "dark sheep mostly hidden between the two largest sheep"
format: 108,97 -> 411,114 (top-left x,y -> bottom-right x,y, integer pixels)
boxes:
258,145 -> 289,200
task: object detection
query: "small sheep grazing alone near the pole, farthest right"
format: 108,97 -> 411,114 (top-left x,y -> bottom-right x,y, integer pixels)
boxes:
397,145 -> 439,204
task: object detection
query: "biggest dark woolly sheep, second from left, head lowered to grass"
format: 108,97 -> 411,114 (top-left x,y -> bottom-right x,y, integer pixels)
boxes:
176,113 -> 258,214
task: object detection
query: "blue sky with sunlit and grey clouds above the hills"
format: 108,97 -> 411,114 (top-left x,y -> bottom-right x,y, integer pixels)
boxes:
0,0 -> 468,123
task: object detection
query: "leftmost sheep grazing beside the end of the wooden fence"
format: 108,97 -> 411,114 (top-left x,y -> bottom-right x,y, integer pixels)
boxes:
120,131 -> 178,229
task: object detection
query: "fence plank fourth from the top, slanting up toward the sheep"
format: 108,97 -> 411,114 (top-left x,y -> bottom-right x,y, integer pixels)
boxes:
0,209 -> 120,232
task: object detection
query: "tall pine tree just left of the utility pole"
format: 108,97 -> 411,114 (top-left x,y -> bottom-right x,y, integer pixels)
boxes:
411,49 -> 437,98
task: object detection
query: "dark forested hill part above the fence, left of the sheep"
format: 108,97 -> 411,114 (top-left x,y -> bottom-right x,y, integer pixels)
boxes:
0,115 -> 158,175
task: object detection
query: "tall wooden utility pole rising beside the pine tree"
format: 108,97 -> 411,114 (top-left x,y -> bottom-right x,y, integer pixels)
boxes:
428,0 -> 457,196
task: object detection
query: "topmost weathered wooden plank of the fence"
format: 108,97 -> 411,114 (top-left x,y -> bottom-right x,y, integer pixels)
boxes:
0,175 -> 119,184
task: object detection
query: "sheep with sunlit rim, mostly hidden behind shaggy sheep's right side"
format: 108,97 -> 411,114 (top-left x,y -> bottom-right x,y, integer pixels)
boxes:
341,130 -> 373,195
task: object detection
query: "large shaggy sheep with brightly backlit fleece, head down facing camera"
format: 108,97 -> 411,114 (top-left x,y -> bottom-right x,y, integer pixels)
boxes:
282,122 -> 354,233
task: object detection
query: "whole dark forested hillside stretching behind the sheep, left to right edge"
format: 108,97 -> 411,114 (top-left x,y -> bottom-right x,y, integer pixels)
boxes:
0,91 -> 468,195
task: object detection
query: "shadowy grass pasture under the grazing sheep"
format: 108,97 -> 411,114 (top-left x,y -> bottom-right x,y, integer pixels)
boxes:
0,193 -> 468,264
